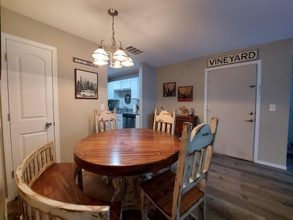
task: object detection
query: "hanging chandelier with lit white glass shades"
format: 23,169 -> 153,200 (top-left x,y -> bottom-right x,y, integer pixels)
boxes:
92,8 -> 134,68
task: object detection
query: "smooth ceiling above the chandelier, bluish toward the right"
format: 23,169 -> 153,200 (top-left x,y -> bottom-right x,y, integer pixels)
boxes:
1,0 -> 293,77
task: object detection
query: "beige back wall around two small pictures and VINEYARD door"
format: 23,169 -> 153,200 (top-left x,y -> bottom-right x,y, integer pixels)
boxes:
156,39 -> 292,166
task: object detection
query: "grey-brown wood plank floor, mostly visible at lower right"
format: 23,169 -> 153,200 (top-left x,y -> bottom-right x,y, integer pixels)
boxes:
9,154 -> 293,220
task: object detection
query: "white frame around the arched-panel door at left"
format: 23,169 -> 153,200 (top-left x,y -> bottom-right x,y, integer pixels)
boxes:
0,32 -> 60,202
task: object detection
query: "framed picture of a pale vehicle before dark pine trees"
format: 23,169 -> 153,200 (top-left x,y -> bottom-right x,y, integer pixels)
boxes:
75,69 -> 98,99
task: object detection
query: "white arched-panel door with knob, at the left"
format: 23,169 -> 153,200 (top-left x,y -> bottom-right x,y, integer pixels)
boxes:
1,33 -> 56,200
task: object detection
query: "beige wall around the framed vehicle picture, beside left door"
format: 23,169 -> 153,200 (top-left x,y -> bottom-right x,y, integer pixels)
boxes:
1,8 -> 108,162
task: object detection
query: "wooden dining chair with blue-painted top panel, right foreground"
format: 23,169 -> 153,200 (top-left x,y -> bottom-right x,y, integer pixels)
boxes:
141,118 -> 218,220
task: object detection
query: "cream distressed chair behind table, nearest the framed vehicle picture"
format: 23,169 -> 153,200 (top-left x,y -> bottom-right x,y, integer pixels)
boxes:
94,108 -> 117,133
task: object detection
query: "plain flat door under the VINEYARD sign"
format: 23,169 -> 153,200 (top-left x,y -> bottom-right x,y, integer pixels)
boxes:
207,64 -> 257,161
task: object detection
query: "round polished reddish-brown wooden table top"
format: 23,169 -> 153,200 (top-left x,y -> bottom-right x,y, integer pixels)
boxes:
74,128 -> 180,176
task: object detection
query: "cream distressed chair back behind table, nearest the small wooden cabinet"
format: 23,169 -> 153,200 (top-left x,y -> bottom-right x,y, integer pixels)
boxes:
153,108 -> 177,134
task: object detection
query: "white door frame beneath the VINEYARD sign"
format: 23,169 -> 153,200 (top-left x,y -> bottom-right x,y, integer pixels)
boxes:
204,60 -> 262,163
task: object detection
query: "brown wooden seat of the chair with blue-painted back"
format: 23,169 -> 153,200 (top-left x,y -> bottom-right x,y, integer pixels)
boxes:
141,170 -> 204,216
